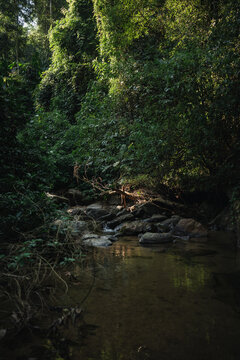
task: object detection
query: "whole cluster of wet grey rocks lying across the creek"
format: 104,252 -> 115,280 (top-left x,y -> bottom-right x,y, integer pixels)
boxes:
55,194 -> 236,253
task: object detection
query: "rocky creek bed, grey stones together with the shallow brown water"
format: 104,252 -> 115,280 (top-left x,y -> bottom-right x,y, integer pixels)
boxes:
0,198 -> 240,360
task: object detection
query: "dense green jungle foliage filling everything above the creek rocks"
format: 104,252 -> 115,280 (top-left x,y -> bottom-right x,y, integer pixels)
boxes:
0,0 -> 240,236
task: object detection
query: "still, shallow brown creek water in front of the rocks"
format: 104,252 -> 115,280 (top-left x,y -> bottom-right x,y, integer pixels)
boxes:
0,234 -> 240,360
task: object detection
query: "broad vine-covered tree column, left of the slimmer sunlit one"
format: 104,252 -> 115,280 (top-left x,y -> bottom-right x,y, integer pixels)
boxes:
37,0 -> 97,122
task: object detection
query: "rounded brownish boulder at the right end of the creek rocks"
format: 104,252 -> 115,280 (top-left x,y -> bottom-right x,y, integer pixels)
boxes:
174,218 -> 208,237
